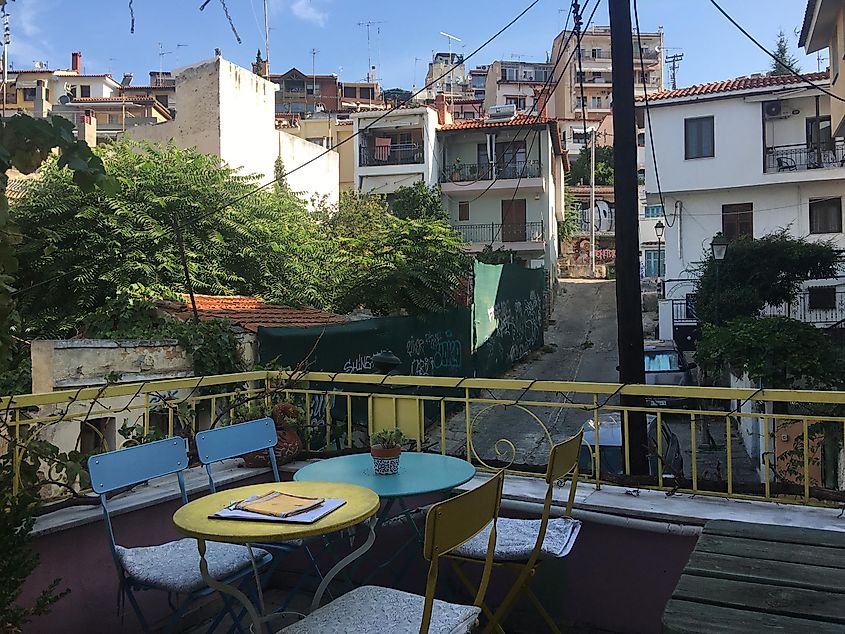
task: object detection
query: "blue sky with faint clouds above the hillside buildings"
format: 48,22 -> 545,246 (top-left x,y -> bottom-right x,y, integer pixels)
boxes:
9,0 -> 826,88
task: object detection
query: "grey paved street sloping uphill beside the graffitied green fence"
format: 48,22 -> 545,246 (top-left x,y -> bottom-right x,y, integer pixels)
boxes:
429,280 -> 757,482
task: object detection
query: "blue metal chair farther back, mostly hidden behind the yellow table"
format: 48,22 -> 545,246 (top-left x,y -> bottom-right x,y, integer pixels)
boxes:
196,418 -> 323,610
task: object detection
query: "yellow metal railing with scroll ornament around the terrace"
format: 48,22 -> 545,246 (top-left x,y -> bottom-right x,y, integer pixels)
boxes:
0,371 -> 845,504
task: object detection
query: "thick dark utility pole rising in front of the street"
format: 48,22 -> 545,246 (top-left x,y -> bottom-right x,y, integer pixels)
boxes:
608,0 -> 648,475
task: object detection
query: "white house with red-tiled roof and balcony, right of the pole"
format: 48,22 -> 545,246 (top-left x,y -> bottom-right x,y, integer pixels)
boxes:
643,73 -> 845,338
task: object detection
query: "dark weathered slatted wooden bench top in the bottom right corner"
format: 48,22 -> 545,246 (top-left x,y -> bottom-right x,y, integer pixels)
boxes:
663,520 -> 845,634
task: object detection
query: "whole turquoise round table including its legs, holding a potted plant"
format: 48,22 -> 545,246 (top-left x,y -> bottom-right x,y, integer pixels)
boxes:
293,451 -> 475,583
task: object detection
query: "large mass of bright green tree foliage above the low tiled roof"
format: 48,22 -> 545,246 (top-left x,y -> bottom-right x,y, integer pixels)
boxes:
9,141 -> 465,337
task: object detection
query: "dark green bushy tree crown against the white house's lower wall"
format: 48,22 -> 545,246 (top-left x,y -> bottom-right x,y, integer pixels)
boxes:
695,229 -> 845,323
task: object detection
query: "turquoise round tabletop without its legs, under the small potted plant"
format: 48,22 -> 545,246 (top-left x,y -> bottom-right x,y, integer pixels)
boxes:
293,451 -> 475,498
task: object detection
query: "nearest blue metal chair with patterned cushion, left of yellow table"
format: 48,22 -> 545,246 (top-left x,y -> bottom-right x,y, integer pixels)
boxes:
88,437 -> 271,632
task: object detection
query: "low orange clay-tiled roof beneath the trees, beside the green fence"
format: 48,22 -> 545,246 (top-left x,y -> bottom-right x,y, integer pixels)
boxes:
158,295 -> 348,332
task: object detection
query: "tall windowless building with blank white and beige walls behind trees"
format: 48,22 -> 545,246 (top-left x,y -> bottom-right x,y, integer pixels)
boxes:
127,57 -> 338,202
